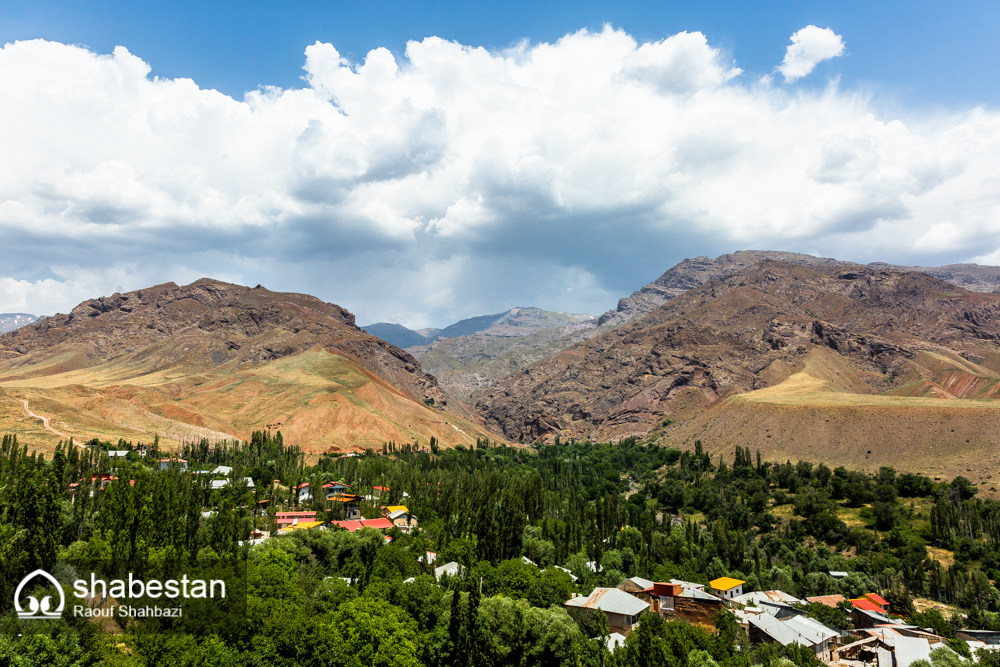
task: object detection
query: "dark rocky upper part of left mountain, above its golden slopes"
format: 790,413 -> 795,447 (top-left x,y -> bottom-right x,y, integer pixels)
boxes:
0,279 -> 447,404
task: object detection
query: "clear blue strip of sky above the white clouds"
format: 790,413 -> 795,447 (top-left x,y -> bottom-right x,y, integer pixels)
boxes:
7,0 -> 1000,107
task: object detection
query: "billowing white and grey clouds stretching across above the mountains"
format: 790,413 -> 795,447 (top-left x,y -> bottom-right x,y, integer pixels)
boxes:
0,26 -> 1000,327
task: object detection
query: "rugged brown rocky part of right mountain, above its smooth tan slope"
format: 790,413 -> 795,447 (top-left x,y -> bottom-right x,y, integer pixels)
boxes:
476,258 -> 1000,440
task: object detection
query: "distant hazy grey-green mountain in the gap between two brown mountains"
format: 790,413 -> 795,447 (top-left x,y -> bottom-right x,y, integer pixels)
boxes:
408,308 -> 598,399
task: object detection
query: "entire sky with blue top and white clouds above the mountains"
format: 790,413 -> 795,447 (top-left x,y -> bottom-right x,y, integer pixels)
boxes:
0,0 -> 1000,328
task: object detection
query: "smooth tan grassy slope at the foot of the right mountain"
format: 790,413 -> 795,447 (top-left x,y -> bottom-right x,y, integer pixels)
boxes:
656,353 -> 1000,496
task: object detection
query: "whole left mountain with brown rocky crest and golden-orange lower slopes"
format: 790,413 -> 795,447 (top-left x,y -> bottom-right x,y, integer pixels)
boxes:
0,279 -> 498,452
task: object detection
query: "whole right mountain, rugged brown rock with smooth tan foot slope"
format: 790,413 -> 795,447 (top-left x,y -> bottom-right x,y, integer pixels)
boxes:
476,260 -> 1000,486
